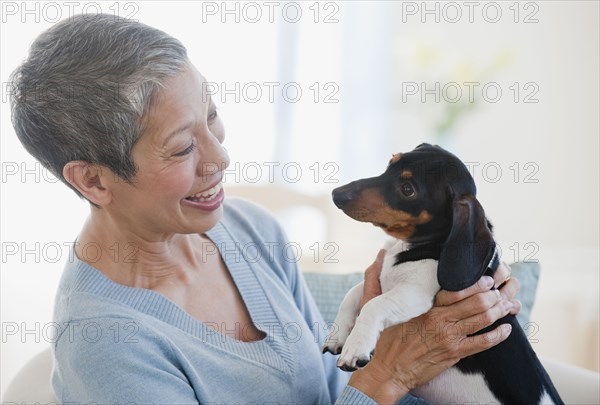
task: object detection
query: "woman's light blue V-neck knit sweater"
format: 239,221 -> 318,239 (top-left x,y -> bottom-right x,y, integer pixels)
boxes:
52,199 -> 426,405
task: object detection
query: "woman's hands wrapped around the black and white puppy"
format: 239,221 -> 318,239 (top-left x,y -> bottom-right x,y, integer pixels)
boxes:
350,251 -> 521,403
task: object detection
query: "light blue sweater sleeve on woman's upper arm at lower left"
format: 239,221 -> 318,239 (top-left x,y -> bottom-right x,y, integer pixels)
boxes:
53,318 -> 198,404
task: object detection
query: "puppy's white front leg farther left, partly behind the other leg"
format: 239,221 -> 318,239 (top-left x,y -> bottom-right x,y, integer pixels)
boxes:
323,282 -> 364,354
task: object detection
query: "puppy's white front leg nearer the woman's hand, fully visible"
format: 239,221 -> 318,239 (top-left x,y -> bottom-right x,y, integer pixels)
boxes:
337,283 -> 439,371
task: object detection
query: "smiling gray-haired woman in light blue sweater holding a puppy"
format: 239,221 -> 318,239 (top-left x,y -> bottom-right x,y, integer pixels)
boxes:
12,15 -> 519,404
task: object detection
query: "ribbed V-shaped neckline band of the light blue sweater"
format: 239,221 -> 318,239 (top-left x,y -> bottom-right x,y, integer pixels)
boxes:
64,222 -> 293,374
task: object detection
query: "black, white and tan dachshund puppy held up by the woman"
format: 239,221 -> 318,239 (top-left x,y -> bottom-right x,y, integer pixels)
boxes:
323,144 -> 563,404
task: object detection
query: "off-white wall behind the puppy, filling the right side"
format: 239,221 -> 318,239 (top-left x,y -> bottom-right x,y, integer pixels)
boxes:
384,1 -> 600,370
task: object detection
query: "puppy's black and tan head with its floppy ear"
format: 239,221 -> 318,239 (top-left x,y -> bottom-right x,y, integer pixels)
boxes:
333,144 -> 495,291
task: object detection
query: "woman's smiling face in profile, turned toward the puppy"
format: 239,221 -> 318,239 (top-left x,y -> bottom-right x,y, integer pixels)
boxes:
107,64 -> 229,239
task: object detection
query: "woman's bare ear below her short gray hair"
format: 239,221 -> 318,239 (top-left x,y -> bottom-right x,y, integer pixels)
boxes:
63,160 -> 112,207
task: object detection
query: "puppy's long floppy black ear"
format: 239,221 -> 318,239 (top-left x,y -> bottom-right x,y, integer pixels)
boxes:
437,195 -> 498,291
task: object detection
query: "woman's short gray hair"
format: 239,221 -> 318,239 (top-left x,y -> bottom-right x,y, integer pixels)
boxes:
10,14 -> 188,196
